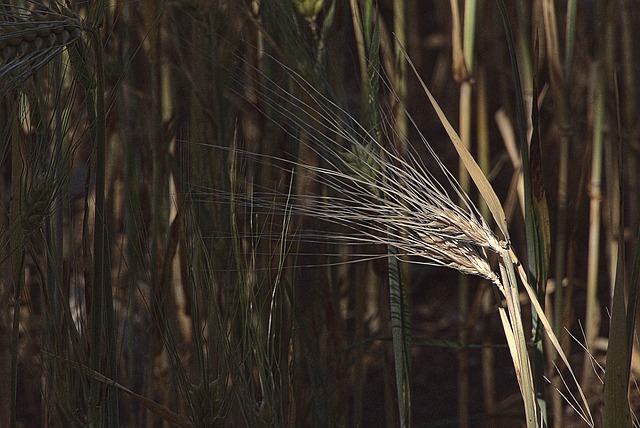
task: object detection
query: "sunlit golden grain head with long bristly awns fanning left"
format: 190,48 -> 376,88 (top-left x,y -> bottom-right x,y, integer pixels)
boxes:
225,56 -> 500,283
